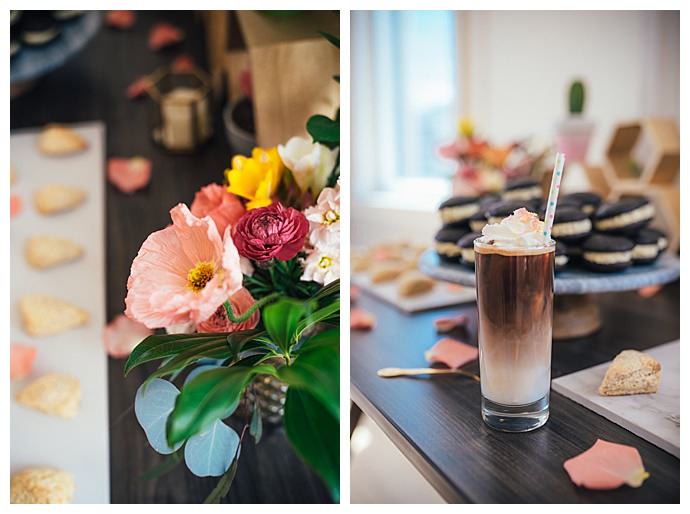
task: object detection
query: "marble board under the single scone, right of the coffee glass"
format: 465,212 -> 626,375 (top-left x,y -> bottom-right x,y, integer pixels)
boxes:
551,341 -> 680,458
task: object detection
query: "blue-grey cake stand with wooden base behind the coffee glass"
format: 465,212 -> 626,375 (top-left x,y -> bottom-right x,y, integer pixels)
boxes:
419,250 -> 680,339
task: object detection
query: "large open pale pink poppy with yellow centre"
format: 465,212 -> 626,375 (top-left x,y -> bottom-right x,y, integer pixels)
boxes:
125,204 -> 242,328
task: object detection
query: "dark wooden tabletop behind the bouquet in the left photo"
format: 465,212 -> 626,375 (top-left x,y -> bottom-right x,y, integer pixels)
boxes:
10,11 -> 330,503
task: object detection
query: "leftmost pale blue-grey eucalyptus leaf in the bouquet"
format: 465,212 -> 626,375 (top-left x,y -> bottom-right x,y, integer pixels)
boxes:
134,378 -> 182,455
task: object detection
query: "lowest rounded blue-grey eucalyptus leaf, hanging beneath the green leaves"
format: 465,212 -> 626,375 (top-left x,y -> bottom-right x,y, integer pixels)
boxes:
184,420 -> 240,477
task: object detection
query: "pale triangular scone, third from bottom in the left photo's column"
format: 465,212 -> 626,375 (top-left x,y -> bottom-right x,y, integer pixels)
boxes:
19,294 -> 89,336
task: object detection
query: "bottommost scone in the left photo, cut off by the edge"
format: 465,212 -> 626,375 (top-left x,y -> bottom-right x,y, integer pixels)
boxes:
10,468 -> 74,503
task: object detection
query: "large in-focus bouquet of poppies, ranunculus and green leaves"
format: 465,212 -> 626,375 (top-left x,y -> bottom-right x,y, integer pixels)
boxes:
125,34 -> 340,502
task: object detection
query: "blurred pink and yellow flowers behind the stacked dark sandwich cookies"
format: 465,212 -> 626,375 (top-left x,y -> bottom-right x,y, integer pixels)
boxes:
439,118 -> 547,195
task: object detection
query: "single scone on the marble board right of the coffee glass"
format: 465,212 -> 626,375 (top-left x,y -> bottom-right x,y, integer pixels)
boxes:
599,350 -> 661,396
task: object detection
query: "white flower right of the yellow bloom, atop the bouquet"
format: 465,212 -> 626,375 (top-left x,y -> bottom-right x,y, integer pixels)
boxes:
278,137 -> 338,195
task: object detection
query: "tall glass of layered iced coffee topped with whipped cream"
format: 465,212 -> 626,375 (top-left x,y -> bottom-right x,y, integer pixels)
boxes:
474,209 -> 555,432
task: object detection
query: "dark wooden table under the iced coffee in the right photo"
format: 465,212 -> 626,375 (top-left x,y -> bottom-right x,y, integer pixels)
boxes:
350,282 -> 680,503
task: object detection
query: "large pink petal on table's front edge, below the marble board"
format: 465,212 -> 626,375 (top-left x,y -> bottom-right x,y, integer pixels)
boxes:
563,439 -> 649,489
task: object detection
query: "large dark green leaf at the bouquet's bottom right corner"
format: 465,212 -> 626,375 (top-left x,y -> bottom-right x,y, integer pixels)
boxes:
283,387 -> 340,502
